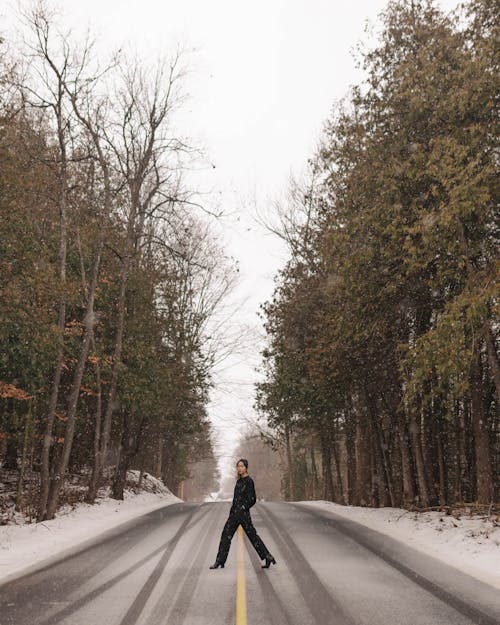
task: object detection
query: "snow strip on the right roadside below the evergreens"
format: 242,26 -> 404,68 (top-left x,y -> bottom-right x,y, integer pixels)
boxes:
297,501 -> 500,589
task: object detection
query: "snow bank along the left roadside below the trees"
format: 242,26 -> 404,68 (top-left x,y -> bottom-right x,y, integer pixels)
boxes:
0,471 -> 182,583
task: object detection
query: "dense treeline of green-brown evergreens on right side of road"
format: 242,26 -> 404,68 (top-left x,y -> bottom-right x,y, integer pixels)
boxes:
257,0 -> 500,508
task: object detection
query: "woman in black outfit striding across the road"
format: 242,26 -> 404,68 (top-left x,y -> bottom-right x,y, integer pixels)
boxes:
210,458 -> 276,569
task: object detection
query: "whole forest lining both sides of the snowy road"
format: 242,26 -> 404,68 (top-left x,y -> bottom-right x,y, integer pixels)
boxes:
0,0 -> 500,523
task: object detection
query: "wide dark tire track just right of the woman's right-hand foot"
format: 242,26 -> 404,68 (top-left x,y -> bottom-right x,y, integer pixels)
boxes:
259,506 -> 354,625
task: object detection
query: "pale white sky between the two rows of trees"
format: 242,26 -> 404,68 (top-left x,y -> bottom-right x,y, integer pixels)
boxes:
0,0 -> 457,482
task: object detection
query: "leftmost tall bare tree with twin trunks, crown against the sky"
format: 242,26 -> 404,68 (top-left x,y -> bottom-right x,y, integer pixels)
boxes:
17,2 -> 123,521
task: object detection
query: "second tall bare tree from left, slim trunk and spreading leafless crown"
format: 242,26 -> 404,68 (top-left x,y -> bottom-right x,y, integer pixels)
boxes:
94,52 -> 196,498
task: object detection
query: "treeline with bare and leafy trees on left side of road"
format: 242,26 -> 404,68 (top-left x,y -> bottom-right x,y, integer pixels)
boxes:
0,3 -> 230,521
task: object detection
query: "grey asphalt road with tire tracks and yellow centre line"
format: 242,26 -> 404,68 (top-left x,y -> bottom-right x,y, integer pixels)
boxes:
0,502 -> 500,625
